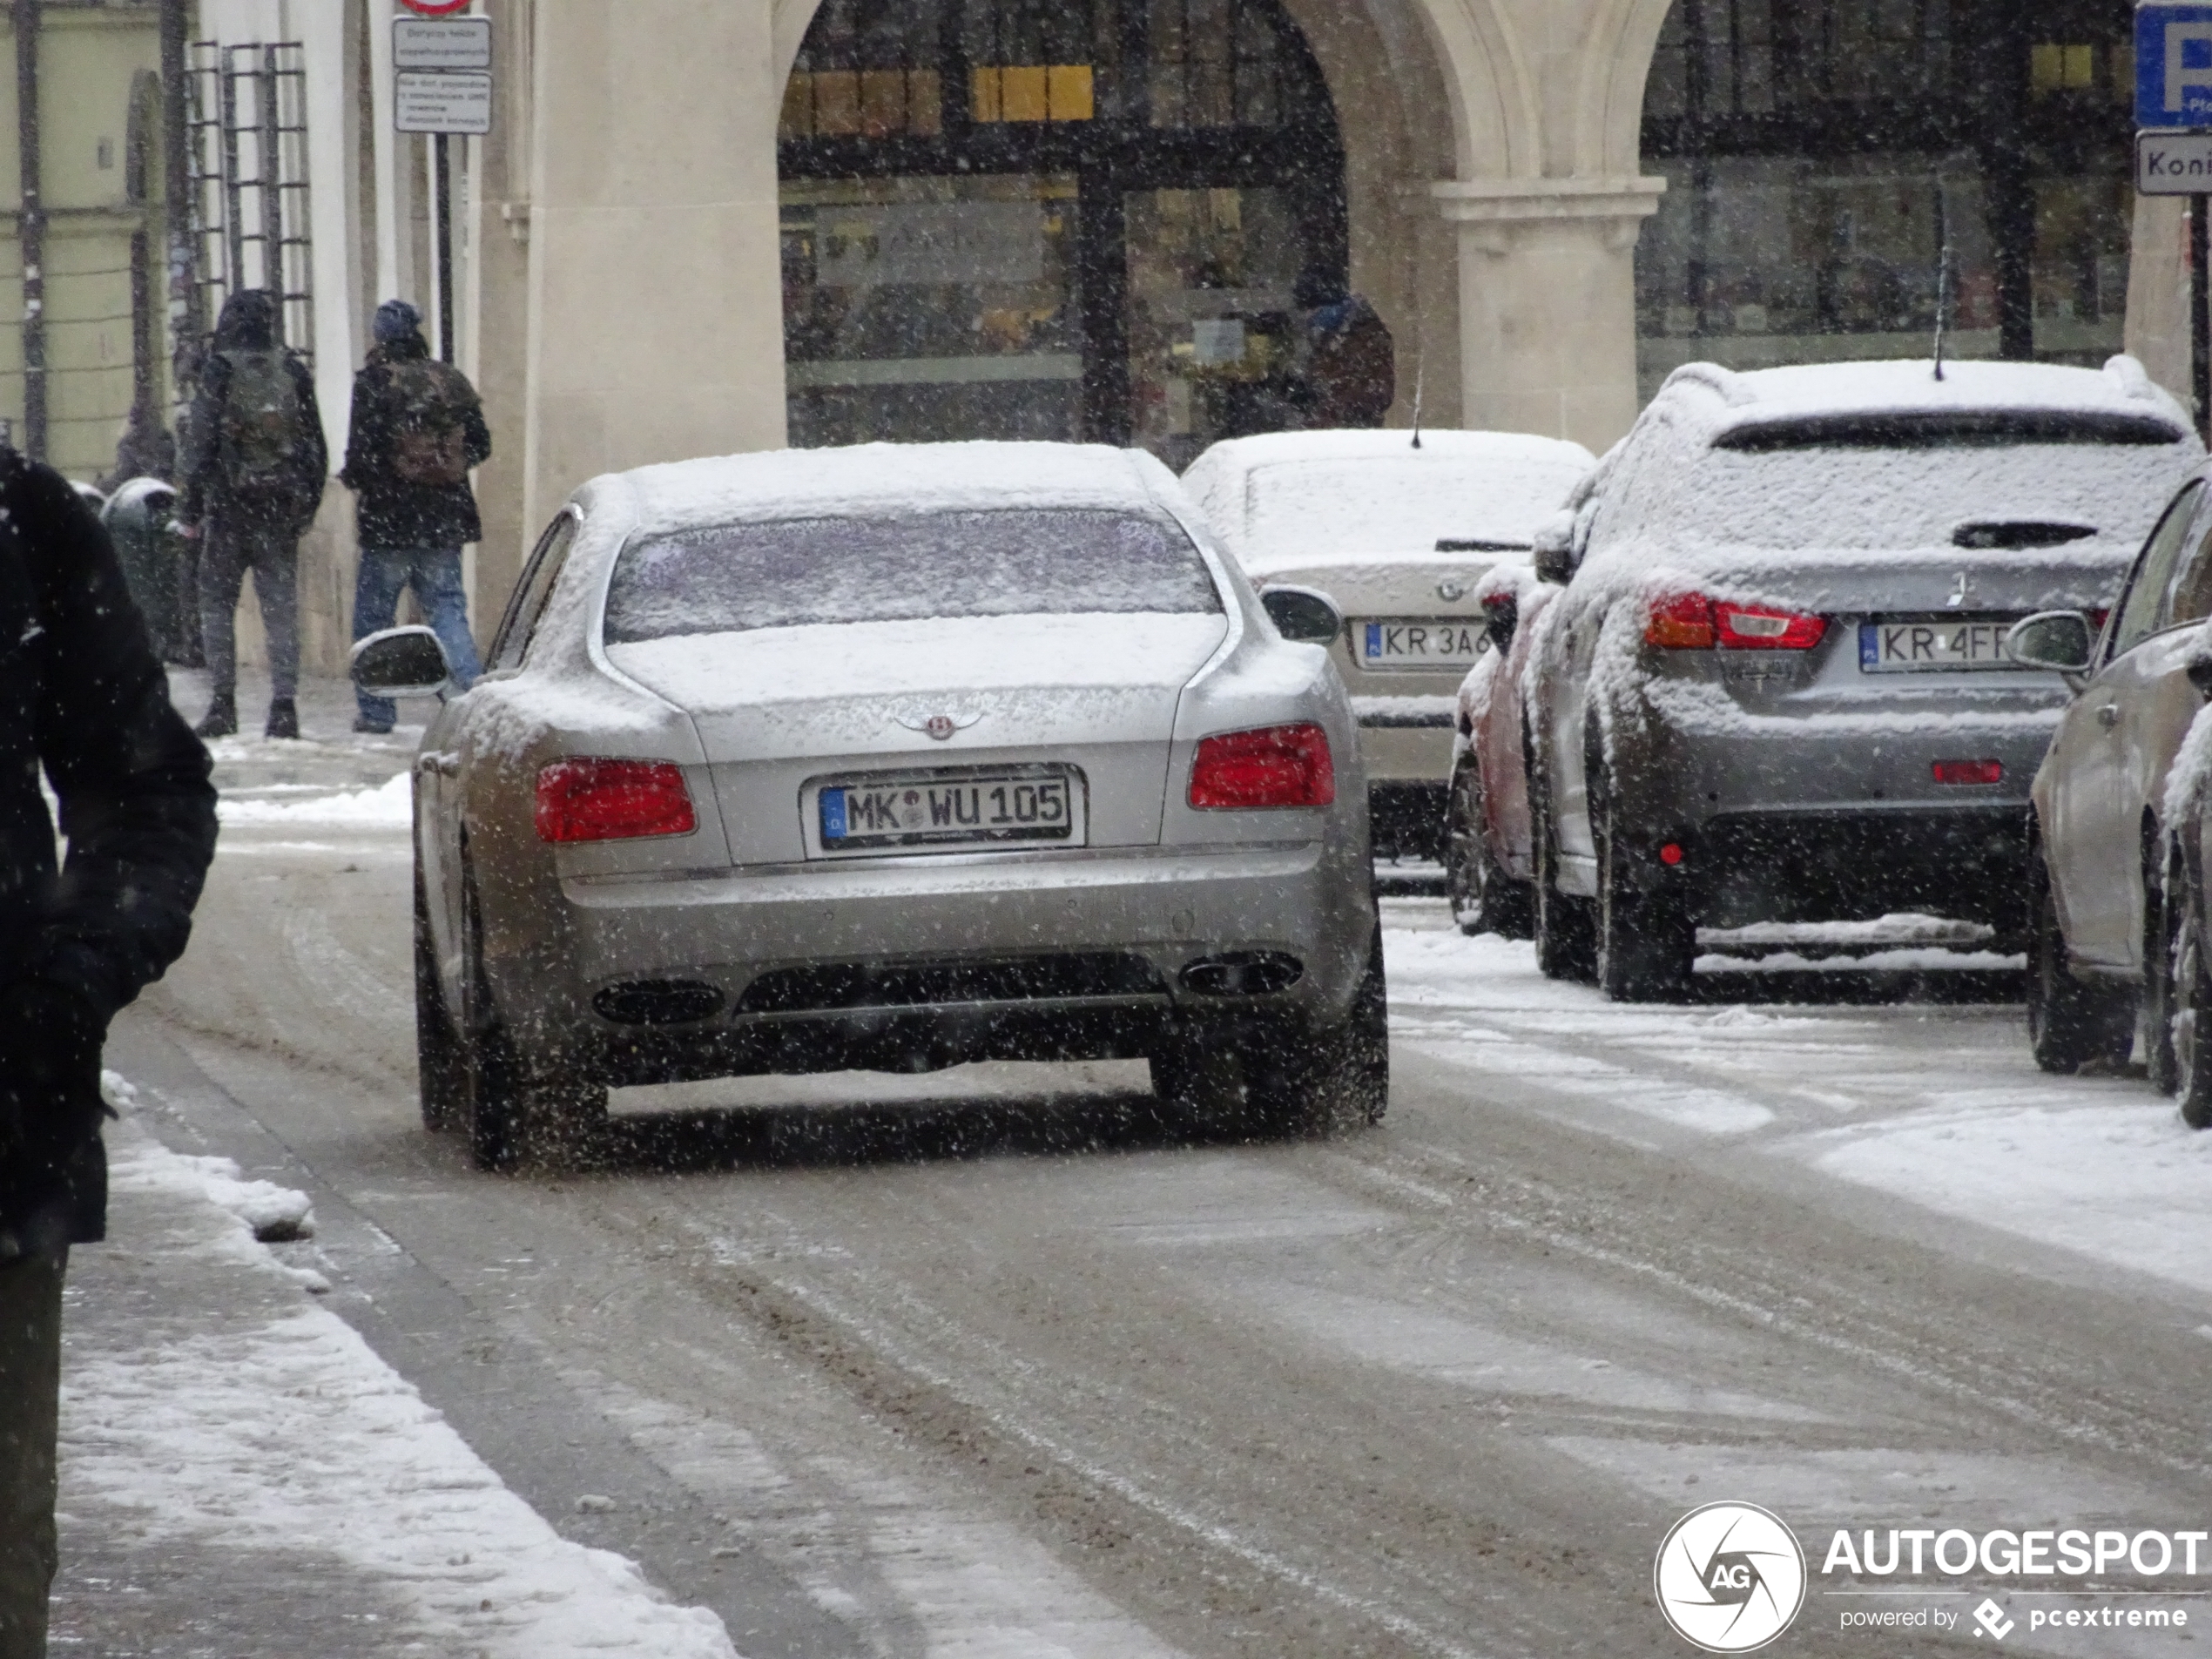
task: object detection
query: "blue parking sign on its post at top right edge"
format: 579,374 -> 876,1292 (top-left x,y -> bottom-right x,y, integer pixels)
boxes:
2134,0 -> 2212,435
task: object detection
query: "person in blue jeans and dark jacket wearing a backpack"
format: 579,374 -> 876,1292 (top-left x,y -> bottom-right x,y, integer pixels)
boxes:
339,299 -> 491,732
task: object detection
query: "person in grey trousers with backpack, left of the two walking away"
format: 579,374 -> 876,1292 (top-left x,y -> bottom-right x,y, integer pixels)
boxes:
177,287 -> 329,737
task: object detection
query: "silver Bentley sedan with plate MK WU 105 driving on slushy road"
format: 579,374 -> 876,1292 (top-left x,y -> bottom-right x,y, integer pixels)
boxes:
354,445 -> 1389,1168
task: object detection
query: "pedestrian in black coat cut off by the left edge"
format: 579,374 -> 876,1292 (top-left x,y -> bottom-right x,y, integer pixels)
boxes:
0,449 -> 214,1659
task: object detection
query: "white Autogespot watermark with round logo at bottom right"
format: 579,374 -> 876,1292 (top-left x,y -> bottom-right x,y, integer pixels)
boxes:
1652,1502 -> 2212,1652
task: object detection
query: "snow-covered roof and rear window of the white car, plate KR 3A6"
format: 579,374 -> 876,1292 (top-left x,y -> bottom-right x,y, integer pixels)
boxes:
1184,429 -> 1593,569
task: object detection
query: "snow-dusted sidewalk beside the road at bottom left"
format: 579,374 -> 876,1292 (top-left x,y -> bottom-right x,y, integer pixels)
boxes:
51,1080 -> 737,1659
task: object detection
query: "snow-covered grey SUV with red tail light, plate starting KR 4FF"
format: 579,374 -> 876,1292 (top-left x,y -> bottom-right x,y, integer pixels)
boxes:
1527,358 -> 2203,998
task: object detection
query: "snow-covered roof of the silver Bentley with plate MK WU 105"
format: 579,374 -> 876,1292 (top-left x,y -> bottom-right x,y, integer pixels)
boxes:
586,442 -> 1188,533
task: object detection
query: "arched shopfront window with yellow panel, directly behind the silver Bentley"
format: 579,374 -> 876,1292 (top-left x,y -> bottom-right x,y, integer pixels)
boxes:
781,0 -> 1347,462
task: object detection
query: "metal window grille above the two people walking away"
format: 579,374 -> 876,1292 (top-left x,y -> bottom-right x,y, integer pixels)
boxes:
185,40 -> 314,358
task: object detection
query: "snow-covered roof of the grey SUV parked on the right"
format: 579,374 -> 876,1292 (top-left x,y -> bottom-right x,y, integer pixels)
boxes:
1659,356 -> 2190,445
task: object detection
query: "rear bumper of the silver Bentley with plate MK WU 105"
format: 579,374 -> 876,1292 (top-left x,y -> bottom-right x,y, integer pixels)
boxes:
487,843 -> 1373,1082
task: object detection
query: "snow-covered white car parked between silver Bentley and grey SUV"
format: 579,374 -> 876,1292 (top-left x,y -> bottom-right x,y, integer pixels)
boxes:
1184,431 -> 1595,859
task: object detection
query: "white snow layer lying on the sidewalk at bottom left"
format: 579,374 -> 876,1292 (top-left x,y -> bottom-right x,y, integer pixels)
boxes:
62,1122 -> 737,1659
